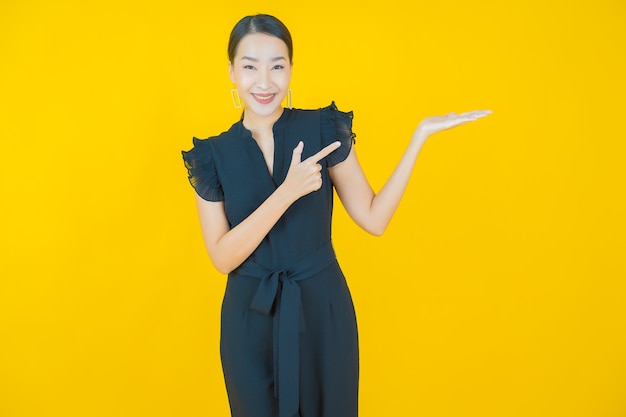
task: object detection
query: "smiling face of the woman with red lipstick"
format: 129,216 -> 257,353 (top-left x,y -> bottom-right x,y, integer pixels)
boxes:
229,33 -> 291,117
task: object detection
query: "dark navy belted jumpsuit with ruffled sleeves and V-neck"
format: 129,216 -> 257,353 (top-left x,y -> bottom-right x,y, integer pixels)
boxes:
183,103 -> 359,417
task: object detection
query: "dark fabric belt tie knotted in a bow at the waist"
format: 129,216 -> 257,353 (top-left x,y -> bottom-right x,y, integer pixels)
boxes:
234,242 -> 335,417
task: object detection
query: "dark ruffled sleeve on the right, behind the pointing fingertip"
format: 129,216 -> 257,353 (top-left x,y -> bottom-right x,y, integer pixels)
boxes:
320,101 -> 356,167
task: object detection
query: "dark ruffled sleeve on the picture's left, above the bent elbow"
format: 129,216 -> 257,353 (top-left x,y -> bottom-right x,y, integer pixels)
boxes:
182,138 -> 224,201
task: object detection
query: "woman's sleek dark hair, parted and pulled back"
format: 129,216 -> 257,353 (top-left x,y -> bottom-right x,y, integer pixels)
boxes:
228,14 -> 293,62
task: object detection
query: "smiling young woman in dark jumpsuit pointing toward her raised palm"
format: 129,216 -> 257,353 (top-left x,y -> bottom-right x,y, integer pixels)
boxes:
183,15 -> 490,417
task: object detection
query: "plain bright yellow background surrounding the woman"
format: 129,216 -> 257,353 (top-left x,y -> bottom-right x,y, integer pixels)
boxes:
0,0 -> 626,417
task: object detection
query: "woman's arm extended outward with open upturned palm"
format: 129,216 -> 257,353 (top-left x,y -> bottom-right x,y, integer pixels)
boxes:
329,110 -> 491,236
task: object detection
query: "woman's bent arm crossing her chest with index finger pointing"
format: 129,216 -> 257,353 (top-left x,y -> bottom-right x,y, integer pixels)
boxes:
196,142 -> 339,274
